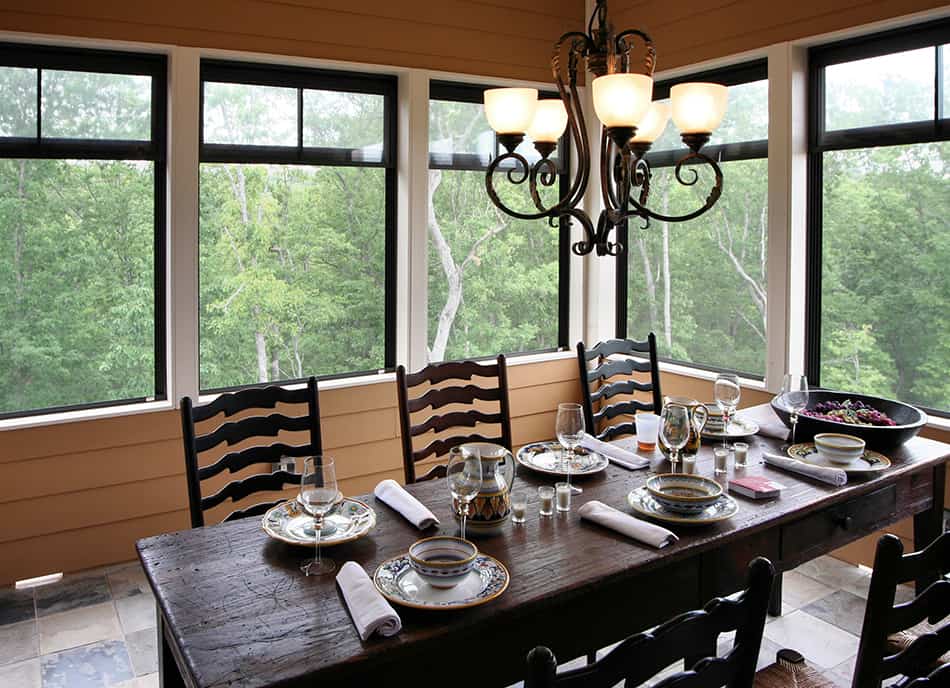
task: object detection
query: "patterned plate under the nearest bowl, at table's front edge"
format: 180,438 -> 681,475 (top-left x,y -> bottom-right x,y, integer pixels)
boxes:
373,554 -> 509,610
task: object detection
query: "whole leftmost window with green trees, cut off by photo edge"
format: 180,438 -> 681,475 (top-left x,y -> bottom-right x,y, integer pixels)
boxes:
0,44 -> 167,417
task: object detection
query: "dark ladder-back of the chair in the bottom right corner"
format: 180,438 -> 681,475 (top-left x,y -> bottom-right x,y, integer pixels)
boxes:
852,533 -> 950,688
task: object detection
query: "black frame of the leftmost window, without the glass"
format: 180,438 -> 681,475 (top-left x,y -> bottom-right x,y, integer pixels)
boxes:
0,42 -> 168,419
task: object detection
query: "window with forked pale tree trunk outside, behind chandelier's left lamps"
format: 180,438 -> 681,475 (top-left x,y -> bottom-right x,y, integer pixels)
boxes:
428,82 -> 570,361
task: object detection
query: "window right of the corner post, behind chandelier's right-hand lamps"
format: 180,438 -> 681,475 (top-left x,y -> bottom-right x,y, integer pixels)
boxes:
617,60 -> 769,379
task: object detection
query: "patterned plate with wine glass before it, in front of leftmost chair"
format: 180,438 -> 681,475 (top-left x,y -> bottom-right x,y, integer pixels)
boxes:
261,497 -> 376,547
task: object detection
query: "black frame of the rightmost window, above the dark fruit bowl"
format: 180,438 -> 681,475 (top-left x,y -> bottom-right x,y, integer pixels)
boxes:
805,19 -> 950,418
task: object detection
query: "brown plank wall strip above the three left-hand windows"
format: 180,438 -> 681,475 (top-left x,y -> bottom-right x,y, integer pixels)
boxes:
0,0 -> 584,81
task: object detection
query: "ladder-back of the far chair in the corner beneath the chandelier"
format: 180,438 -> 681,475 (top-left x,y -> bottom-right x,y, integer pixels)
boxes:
577,332 -> 663,441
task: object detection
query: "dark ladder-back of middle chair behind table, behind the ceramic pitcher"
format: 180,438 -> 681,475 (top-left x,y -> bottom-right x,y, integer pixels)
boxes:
396,356 -> 511,485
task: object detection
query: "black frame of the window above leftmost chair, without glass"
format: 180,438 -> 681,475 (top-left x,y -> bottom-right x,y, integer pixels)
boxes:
197,59 -> 398,395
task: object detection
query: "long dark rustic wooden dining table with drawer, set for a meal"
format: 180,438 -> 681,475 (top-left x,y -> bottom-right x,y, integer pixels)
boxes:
137,406 -> 950,688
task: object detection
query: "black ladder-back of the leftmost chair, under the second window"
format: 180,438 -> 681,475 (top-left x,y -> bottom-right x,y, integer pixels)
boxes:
181,377 -> 323,528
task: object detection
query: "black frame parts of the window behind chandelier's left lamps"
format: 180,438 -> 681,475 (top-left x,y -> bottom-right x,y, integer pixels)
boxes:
427,79 -> 572,360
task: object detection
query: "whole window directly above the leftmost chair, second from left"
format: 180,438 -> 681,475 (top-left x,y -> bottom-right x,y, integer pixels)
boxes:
199,61 -> 396,391
